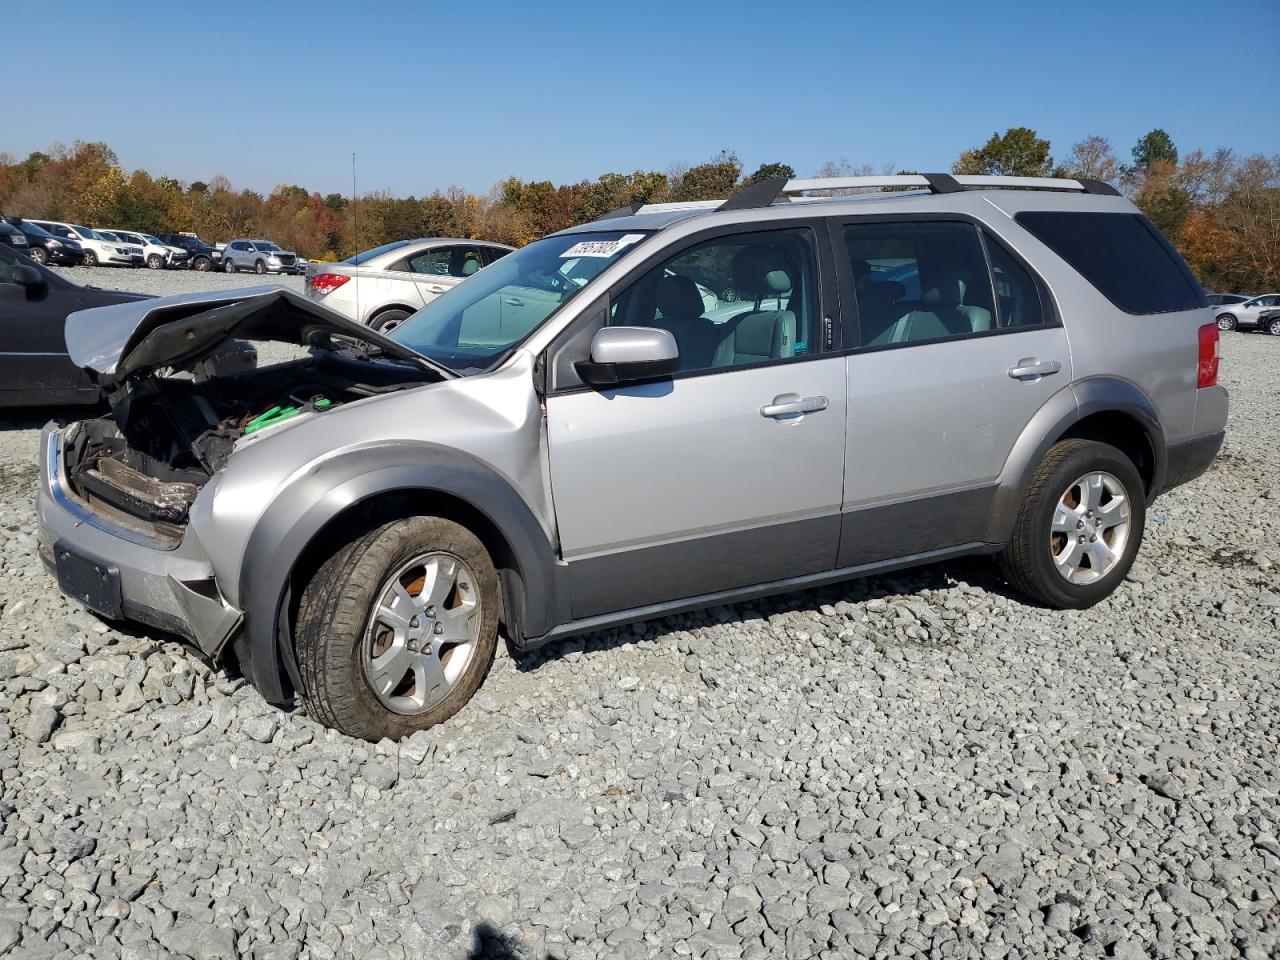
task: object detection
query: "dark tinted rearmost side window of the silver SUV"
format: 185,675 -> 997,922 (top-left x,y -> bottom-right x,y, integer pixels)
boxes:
1015,210 -> 1204,314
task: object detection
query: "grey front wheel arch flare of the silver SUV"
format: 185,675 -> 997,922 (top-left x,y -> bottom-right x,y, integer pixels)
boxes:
234,442 -> 564,703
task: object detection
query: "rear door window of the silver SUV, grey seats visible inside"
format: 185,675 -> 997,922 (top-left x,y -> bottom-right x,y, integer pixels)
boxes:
845,220 -> 998,347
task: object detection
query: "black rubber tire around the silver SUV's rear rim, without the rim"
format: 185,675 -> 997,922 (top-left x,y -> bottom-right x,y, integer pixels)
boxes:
1000,439 -> 1147,609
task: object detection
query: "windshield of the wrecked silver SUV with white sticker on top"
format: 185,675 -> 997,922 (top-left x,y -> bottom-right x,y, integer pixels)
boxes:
390,230 -> 646,374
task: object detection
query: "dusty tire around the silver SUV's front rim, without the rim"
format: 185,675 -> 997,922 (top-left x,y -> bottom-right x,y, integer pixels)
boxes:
294,517 -> 498,741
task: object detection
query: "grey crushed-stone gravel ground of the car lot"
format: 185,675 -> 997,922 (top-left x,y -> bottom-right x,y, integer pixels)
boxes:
0,264 -> 1280,959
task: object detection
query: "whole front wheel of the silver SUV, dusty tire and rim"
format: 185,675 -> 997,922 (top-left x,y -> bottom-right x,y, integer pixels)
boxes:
296,517 -> 498,741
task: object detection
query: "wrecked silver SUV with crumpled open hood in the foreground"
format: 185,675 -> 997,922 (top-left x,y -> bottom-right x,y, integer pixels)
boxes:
40,175 -> 1228,740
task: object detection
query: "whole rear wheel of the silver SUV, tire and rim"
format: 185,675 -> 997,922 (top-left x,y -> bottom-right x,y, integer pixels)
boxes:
1000,439 -> 1147,609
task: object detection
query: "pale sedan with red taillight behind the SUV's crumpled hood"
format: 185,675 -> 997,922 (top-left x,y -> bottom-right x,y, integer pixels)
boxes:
305,237 -> 512,333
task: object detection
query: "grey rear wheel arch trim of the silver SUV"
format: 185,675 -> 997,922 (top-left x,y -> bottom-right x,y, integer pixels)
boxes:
987,376 -> 1167,543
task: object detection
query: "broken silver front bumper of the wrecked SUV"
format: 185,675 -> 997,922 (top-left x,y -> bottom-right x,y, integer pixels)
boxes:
36,424 -> 243,657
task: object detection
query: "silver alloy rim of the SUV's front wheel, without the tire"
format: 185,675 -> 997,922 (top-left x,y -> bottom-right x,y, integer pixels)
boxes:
361,552 -> 483,714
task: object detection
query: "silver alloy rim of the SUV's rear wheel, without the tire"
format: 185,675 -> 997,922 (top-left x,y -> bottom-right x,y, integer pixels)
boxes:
1048,471 -> 1132,584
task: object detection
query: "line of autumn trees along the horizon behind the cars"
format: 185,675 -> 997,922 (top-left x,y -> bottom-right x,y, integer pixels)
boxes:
0,127 -> 1280,292
